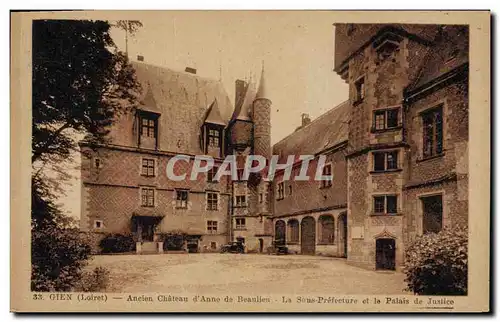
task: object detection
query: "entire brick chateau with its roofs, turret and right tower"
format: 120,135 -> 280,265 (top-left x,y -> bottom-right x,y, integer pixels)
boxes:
81,24 -> 468,269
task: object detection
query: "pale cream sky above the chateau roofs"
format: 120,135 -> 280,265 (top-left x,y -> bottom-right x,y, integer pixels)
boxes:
56,11 -> 348,218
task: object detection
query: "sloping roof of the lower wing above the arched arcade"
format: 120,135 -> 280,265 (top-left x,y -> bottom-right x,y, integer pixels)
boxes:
273,101 -> 350,163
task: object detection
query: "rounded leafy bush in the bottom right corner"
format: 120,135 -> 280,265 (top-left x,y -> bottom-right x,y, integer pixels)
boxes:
405,227 -> 468,295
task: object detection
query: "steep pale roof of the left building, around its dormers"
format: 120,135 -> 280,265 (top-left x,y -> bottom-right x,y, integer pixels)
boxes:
131,62 -> 233,154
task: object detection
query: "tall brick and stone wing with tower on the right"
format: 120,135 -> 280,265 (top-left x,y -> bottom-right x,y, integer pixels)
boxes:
336,24 -> 468,269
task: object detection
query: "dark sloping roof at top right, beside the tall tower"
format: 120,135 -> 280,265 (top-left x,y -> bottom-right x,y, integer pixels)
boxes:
408,26 -> 469,91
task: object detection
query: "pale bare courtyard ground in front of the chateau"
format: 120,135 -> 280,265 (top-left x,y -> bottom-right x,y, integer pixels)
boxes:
88,253 -> 405,295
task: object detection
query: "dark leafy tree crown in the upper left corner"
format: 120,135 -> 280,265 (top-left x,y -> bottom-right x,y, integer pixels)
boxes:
32,20 -> 140,163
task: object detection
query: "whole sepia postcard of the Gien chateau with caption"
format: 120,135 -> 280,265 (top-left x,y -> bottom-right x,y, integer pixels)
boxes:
11,11 -> 490,312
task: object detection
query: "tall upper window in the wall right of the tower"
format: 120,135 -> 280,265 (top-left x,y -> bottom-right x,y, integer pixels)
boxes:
422,107 -> 443,158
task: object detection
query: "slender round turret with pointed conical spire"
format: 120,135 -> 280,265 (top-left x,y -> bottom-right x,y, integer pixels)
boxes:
252,64 -> 272,160
